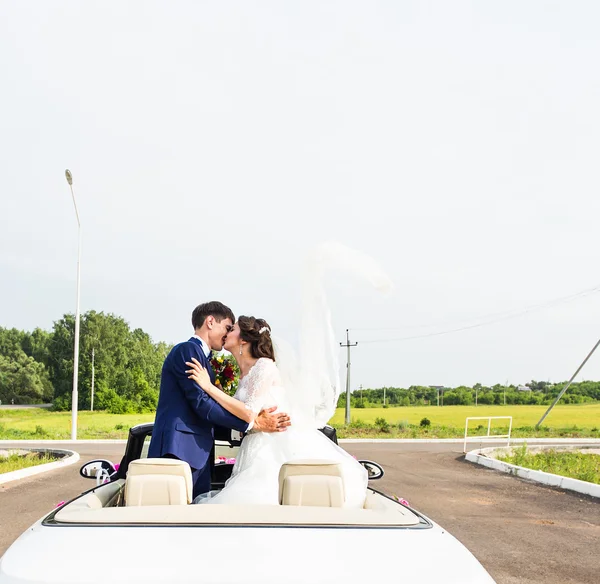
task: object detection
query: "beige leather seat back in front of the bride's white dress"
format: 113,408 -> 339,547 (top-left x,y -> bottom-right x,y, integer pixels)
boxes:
279,459 -> 345,507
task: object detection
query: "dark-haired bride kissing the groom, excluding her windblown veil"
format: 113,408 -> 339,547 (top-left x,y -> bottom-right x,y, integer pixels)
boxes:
187,316 -> 368,508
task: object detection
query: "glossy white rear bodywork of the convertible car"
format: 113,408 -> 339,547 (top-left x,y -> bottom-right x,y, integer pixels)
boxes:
0,487 -> 493,584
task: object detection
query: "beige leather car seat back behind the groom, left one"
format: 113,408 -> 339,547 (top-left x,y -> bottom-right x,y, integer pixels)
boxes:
125,458 -> 192,507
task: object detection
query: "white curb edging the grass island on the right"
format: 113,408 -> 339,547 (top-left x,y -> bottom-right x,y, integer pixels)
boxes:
465,448 -> 600,497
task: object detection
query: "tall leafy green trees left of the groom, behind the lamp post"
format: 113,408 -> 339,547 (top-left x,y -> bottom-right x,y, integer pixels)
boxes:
0,310 -> 171,413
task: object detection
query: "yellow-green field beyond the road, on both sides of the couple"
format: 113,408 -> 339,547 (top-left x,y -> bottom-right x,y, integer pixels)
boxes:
0,404 -> 600,440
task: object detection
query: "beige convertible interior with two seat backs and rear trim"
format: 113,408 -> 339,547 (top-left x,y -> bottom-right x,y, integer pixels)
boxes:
53,428 -> 422,527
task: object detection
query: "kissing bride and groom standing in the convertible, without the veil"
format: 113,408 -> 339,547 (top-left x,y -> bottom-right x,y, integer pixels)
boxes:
148,301 -> 368,508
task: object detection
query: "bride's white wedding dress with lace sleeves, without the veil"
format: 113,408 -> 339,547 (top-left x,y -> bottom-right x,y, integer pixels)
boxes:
194,358 -> 368,508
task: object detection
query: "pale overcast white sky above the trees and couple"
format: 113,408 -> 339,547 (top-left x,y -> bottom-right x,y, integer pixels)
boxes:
0,0 -> 600,389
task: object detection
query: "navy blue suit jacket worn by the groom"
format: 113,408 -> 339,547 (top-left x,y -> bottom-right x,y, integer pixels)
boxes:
148,337 -> 248,469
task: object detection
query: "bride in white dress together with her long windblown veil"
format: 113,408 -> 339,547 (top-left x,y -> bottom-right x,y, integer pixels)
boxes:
187,242 -> 391,508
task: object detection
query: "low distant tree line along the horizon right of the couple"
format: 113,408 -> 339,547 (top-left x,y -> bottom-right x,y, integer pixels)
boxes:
338,381 -> 600,408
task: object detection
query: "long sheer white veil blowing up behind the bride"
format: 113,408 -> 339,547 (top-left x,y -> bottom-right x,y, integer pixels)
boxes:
273,242 -> 392,428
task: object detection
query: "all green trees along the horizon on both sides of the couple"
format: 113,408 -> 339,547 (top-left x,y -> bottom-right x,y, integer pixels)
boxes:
0,310 -> 600,413
